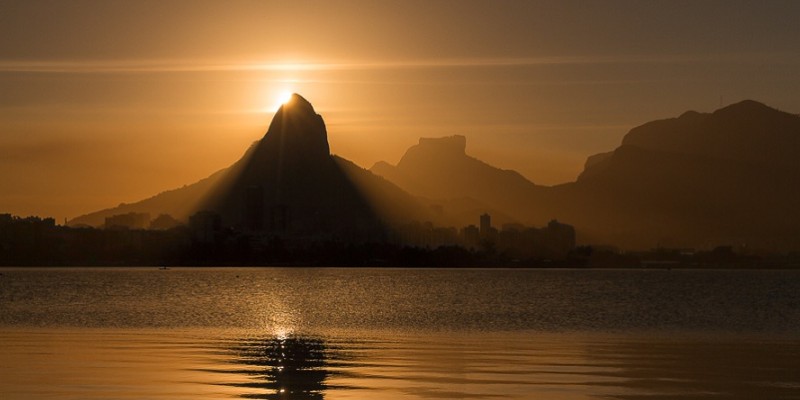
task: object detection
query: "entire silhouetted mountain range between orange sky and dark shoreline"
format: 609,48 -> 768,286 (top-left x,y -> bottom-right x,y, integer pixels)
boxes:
69,95 -> 800,251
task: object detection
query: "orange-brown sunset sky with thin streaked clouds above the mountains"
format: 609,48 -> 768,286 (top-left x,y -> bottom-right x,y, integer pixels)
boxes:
0,0 -> 800,222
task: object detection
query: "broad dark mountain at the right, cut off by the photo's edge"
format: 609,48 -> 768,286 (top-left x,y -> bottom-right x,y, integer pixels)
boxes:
564,100 -> 800,250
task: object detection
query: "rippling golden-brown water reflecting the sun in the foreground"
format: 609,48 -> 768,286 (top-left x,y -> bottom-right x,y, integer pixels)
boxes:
0,268 -> 800,399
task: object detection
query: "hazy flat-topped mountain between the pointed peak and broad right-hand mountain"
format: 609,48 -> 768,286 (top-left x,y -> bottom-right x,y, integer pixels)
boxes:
370,135 -> 542,225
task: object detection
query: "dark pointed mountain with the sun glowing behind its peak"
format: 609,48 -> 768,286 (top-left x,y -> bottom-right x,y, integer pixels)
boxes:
70,94 -> 428,239
